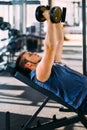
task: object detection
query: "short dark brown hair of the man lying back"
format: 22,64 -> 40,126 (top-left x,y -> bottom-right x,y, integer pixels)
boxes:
15,51 -> 31,76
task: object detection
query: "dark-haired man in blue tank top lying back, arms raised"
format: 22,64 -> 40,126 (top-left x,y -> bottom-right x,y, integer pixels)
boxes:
16,11 -> 87,111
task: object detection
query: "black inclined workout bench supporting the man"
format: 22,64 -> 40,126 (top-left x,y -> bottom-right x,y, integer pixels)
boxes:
6,66 -> 87,130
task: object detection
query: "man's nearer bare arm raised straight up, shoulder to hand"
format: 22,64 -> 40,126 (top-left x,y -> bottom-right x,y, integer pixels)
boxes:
36,11 -> 61,82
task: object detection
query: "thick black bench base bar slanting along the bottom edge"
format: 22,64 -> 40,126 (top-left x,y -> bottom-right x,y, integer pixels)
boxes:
27,115 -> 80,130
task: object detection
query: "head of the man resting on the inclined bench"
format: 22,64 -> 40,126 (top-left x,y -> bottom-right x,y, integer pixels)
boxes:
16,51 -> 41,74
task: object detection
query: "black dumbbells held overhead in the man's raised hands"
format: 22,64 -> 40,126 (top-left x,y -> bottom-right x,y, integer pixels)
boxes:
35,5 -> 66,23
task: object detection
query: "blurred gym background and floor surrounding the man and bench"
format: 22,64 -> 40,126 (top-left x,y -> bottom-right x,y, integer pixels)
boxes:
0,0 -> 87,130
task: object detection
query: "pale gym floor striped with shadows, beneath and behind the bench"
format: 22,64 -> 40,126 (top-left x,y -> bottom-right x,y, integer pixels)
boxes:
0,34 -> 86,130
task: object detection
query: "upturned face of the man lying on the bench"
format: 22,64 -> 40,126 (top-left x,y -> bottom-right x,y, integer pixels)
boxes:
23,52 -> 41,63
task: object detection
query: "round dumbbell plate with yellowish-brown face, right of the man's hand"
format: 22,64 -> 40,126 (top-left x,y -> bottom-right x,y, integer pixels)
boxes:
50,6 -> 62,23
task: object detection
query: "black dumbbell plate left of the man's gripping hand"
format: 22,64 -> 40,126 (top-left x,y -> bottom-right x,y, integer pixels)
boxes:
35,6 -> 47,22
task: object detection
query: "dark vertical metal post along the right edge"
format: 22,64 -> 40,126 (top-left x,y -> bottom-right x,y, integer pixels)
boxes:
82,0 -> 86,75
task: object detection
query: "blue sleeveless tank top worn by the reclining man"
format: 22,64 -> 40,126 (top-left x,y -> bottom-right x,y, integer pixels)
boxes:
30,63 -> 87,109
